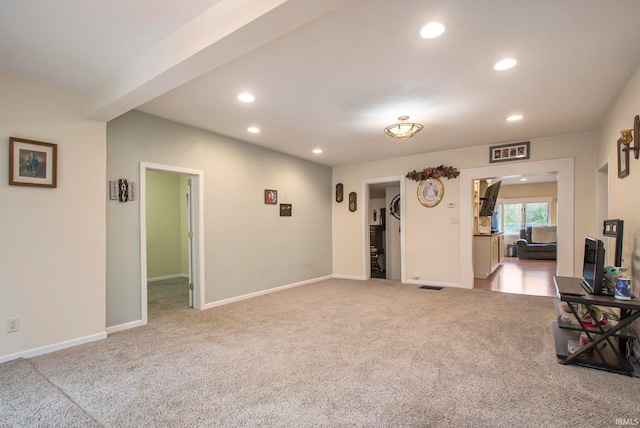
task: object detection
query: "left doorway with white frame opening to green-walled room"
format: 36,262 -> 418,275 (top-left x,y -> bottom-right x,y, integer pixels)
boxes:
139,162 -> 204,324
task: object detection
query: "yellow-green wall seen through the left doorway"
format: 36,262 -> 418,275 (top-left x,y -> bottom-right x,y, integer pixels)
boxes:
146,171 -> 189,280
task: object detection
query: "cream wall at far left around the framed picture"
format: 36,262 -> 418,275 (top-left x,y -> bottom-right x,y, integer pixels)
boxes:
0,72 -> 108,362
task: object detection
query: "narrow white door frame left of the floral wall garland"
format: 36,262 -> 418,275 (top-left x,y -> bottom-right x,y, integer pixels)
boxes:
361,175 -> 407,284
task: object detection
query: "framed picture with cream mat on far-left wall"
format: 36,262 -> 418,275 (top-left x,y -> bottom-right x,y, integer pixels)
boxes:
9,137 -> 58,188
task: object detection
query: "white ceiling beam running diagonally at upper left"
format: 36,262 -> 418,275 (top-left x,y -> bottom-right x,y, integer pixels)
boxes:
88,0 -> 351,122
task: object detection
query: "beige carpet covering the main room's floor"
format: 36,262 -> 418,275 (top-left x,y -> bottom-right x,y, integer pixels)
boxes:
0,279 -> 640,427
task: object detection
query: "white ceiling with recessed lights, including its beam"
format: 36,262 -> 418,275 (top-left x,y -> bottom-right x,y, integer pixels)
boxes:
0,0 -> 640,165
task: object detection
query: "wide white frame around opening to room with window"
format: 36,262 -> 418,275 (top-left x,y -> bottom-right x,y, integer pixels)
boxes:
459,158 -> 575,288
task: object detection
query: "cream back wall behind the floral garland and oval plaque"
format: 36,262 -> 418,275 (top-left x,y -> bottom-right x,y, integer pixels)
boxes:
333,133 -> 596,286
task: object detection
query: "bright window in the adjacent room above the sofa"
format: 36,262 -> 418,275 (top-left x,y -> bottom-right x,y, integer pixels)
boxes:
498,197 -> 551,235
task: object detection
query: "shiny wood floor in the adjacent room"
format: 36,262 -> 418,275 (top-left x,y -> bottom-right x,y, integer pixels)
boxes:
474,257 -> 556,297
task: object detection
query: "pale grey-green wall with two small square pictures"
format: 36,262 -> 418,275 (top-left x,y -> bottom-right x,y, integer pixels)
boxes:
107,111 -> 332,327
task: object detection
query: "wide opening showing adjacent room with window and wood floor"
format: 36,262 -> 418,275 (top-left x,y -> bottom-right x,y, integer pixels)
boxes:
473,171 -> 558,296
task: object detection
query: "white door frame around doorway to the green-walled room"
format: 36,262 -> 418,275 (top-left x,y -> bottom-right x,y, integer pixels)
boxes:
138,162 -> 205,325
